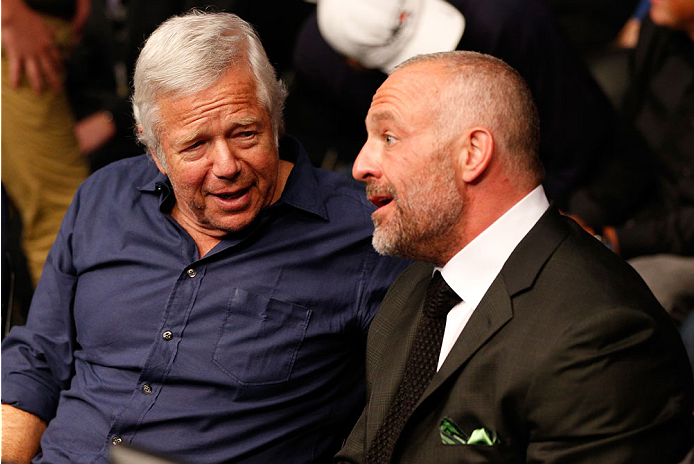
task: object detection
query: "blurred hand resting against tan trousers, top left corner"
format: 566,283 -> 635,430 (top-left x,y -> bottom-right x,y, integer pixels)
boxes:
1,0 -> 63,94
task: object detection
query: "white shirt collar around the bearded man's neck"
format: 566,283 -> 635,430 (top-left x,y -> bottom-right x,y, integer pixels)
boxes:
441,186 -> 549,308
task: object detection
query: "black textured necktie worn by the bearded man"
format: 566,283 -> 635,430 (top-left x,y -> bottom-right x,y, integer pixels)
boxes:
366,271 -> 461,464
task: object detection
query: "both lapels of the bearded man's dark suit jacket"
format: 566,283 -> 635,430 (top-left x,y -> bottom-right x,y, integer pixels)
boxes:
365,208 -> 569,443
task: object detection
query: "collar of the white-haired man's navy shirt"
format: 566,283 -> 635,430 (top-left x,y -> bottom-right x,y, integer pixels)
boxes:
138,135 -> 328,221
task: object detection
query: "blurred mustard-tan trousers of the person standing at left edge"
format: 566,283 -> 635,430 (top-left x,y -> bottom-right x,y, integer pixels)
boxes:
0,17 -> 89,285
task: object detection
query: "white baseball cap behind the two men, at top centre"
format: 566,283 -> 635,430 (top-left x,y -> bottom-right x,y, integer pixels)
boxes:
317,0 -> 464,73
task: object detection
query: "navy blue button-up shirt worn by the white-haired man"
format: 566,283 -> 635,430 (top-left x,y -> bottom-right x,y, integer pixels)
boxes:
2,137 -> 407,463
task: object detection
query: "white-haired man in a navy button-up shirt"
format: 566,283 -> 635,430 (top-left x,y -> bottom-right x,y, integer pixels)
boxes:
2,12 -> 405,463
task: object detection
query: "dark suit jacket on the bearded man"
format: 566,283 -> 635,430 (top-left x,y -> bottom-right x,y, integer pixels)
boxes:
336,209 -> 694,464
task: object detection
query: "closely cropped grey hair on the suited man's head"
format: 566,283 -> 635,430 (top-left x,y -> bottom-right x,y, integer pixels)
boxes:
393,51 -> 544,186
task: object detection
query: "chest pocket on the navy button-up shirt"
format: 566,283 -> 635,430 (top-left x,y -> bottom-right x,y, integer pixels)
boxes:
213,288 -> 311,385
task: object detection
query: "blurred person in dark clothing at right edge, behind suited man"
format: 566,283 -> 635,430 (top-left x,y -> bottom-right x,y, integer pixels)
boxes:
571,0 -> 694,384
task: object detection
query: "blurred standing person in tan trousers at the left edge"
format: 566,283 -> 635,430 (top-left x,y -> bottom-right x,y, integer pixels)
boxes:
1,0 -> 90,285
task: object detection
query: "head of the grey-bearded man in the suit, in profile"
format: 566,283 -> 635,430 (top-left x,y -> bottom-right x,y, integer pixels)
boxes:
352,52 -> 543,265
